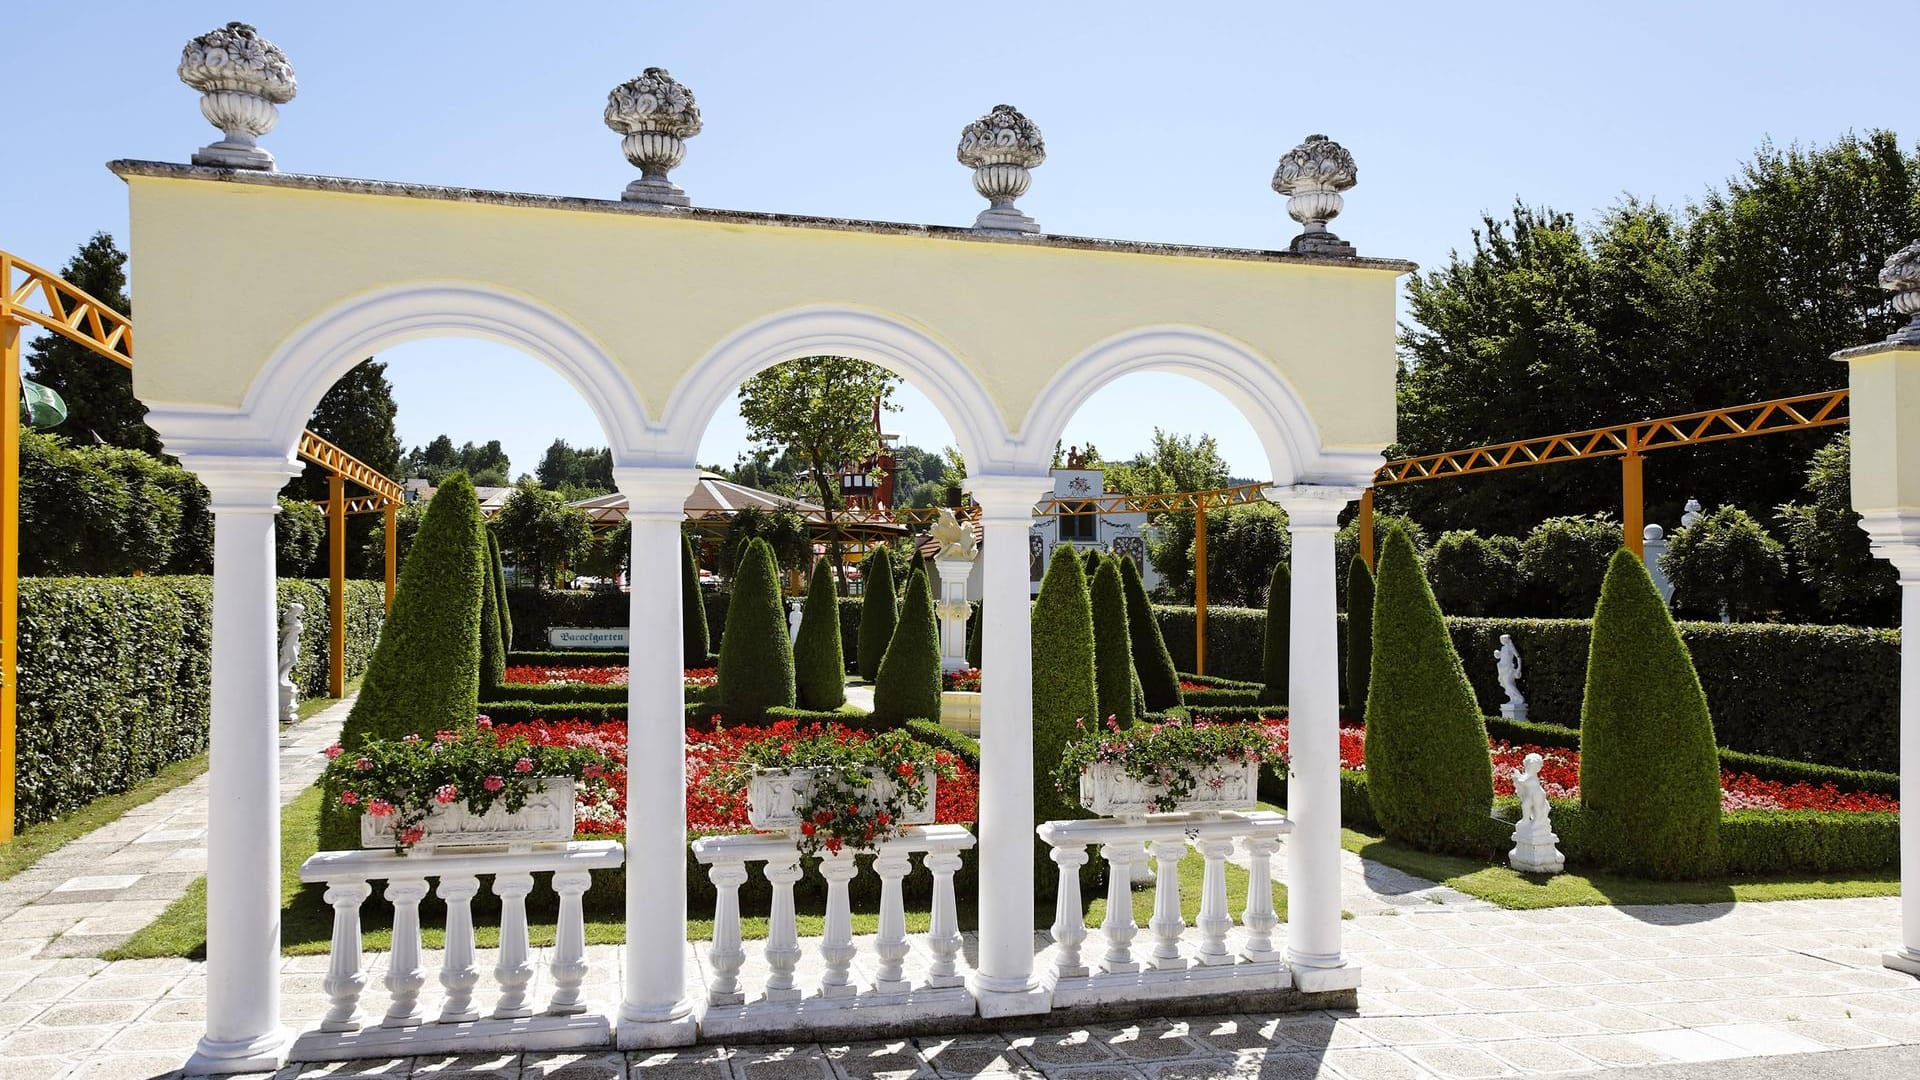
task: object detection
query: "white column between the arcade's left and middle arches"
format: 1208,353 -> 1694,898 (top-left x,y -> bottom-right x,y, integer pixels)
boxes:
614,467 -> 697,1049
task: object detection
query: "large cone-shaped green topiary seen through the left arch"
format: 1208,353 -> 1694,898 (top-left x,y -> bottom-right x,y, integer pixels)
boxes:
340,473 -> 486,748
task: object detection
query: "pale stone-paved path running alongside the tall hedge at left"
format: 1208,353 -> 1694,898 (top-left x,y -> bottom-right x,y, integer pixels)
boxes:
0,698 -> 353,959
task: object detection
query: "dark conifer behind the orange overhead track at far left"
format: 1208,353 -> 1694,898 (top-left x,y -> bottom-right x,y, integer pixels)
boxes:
27,233 -> 161,454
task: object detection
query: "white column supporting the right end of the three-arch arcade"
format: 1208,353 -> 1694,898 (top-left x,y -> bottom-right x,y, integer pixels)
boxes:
1269,484 -> 1359,992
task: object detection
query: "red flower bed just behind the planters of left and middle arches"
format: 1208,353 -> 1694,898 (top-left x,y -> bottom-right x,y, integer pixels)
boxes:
495,721 -> 979,834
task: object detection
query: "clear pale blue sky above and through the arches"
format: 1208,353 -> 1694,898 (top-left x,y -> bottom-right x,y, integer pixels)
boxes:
0,0 -> 1916,475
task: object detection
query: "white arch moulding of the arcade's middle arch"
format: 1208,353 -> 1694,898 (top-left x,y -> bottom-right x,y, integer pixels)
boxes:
662,306 -> 1012,475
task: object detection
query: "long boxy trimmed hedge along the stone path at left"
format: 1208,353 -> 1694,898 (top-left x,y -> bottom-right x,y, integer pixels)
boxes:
13,577 -> 386,828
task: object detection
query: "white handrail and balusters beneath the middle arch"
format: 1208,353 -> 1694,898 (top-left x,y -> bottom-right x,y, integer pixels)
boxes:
691,824 -> 973,1022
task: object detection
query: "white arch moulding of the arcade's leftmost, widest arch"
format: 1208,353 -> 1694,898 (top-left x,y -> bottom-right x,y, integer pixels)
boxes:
240,281 -> 645,465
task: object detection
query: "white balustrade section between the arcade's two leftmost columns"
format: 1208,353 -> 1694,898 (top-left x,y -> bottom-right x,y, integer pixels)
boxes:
296,840 -> 626,1061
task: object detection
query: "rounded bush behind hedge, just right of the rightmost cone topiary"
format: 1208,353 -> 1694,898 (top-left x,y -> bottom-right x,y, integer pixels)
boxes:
1661,505 -> 1788,621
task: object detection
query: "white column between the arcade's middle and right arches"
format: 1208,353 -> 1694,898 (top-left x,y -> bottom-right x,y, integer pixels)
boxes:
966,475 -> 1052,1017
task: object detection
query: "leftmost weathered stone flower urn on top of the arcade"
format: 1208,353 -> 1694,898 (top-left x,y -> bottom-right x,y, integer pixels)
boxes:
180,23 -> 300,171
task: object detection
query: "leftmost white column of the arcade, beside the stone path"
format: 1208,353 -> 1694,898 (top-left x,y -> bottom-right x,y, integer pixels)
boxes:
180,454 -> 300,1074
